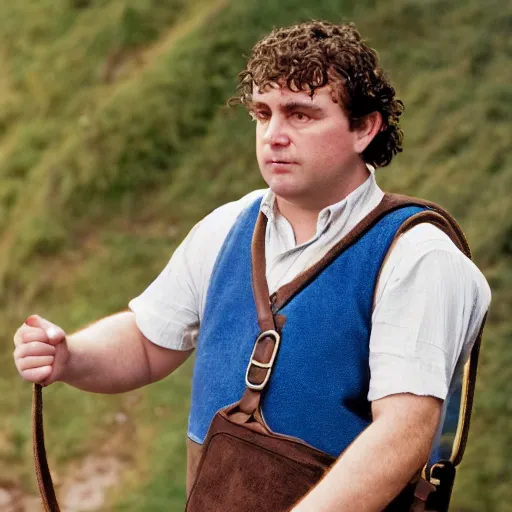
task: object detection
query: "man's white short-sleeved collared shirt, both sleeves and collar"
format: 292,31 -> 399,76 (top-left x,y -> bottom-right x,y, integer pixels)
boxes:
129,171 -> 491,401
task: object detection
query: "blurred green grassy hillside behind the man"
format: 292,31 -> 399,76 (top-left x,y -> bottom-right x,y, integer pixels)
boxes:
0,0 -> 512,512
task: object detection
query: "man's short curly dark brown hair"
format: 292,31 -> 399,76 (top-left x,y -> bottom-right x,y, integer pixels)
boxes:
229,20 -> 404,167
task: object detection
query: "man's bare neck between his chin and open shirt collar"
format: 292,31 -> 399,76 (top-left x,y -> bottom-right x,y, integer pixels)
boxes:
276,164 -> 369,245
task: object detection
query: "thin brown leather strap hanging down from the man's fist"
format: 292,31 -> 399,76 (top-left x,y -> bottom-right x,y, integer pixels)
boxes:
32,384 -> 60,512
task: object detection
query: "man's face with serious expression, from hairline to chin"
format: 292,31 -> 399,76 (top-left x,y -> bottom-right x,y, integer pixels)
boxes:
250,84 -> 364,209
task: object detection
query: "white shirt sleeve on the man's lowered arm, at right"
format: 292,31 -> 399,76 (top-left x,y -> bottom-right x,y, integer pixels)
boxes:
368,224 -> 491,401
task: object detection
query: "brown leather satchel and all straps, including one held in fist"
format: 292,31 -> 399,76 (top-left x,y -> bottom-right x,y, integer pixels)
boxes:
33,194 -> 483,512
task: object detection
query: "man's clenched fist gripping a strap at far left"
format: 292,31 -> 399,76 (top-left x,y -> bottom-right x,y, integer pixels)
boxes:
14,315 -> 69,385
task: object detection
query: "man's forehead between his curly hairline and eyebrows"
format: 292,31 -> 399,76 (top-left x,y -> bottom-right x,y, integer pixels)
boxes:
252,82 -> 337,107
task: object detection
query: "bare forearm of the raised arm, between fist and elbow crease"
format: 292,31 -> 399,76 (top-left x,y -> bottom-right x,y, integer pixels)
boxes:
59,312 -> 151,393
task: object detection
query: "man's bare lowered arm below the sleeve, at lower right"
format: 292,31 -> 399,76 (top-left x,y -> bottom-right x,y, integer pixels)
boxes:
293,397 -> 441,512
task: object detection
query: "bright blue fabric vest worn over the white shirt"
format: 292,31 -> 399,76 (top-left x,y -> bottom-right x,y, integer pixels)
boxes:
188,200 -> 424,457
